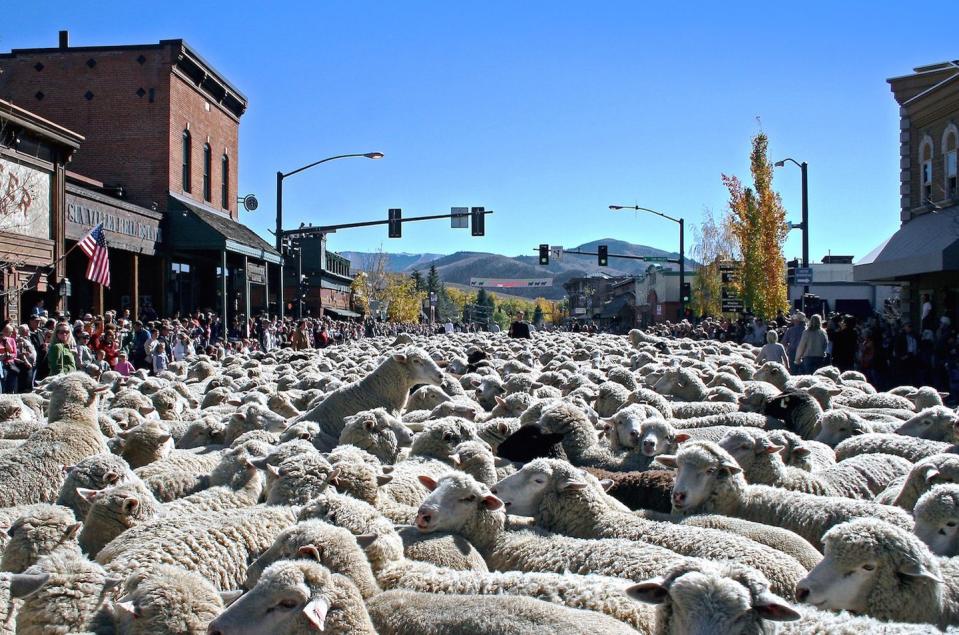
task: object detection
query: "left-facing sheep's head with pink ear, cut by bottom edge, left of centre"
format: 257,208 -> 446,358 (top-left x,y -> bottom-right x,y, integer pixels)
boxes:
207,560 -> 338,635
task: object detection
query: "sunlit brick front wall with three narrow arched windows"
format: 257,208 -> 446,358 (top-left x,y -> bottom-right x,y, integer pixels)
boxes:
169,73 -> 239,219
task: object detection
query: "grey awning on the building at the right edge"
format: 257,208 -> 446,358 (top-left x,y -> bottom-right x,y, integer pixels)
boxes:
853,206 -> 959,282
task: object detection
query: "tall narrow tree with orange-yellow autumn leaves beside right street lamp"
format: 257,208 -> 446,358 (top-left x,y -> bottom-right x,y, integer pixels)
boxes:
722,132 -> 789,319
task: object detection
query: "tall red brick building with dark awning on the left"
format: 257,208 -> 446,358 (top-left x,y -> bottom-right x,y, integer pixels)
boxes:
0,31 -> 280,320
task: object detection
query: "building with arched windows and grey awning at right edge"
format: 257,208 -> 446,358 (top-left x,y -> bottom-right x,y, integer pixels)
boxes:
854,61 -> 959,322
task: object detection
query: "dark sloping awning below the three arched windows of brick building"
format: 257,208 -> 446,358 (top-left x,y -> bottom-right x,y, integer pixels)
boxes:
167,193 -> 282,264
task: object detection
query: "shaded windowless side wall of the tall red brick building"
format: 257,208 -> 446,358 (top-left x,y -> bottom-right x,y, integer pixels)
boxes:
0,48 -> 170,207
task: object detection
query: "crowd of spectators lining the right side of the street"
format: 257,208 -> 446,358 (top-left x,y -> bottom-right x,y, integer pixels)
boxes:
651,297 -> 959,404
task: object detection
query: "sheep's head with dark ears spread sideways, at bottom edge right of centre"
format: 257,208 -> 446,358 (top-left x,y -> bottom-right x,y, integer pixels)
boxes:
626,571 -> 800,635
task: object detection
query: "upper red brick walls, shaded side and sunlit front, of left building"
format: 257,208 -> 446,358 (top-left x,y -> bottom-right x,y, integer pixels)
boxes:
0,44 -> 239,218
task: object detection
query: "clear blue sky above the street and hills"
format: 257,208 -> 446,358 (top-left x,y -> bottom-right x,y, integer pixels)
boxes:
0,0 -> 959,261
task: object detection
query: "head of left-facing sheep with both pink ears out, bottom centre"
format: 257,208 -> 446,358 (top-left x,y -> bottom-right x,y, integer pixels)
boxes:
416,475 -> 503,533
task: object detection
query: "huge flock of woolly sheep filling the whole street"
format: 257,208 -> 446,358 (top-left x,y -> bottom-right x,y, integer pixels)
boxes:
0,331 -> 959,635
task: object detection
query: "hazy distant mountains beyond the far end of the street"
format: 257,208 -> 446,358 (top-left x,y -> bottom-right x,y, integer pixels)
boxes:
340,238 -> 696,300
